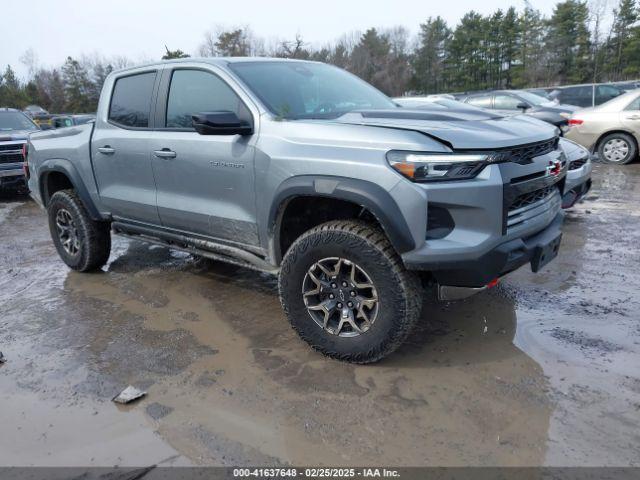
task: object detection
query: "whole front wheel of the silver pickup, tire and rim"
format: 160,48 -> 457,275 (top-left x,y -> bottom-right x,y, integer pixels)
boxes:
279,221 -> 422,363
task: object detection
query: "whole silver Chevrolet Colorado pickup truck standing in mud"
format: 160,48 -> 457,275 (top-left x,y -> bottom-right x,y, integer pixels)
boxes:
27,58 -> 567,363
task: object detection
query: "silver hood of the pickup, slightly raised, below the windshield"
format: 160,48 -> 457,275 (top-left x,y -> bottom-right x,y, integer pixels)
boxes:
334,108 -> 556,150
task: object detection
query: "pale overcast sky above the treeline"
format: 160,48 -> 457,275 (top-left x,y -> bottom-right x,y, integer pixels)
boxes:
0,0 -> 568,77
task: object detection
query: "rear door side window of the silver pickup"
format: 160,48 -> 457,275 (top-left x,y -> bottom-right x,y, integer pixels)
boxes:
109,72 -> 156,128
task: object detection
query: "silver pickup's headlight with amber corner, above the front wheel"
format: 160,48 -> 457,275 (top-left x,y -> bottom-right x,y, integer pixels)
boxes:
387,150 -> 488,182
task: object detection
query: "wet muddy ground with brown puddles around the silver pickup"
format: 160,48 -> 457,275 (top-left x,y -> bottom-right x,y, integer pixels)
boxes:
0,163 -> 640,466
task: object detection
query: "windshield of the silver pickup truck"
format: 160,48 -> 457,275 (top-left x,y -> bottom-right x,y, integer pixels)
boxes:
229,62 -> 397,119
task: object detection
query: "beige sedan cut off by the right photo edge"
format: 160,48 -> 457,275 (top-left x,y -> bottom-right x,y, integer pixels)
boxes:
565,90 -> 640,164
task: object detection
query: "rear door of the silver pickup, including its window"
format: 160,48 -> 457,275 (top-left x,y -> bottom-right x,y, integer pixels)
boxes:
91,70 -> 160,225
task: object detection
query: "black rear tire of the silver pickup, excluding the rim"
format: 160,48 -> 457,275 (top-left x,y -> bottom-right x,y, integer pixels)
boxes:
47,190 -> 111,272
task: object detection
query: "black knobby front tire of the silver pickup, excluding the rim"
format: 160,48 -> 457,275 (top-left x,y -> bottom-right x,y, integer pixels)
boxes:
279,220 -> 422,364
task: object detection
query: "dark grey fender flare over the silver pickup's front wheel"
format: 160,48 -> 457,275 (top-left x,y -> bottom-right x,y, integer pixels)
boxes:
267,175 -> 416,261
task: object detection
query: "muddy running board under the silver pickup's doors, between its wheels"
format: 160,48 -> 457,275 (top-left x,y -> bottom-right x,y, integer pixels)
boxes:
111,222 -> 280,275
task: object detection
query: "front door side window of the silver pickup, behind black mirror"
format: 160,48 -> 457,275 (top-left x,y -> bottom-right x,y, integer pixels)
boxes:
165,70 -> 251,128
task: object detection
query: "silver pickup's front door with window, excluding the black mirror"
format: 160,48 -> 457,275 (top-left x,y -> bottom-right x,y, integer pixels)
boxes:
150,64 -> 259,245
